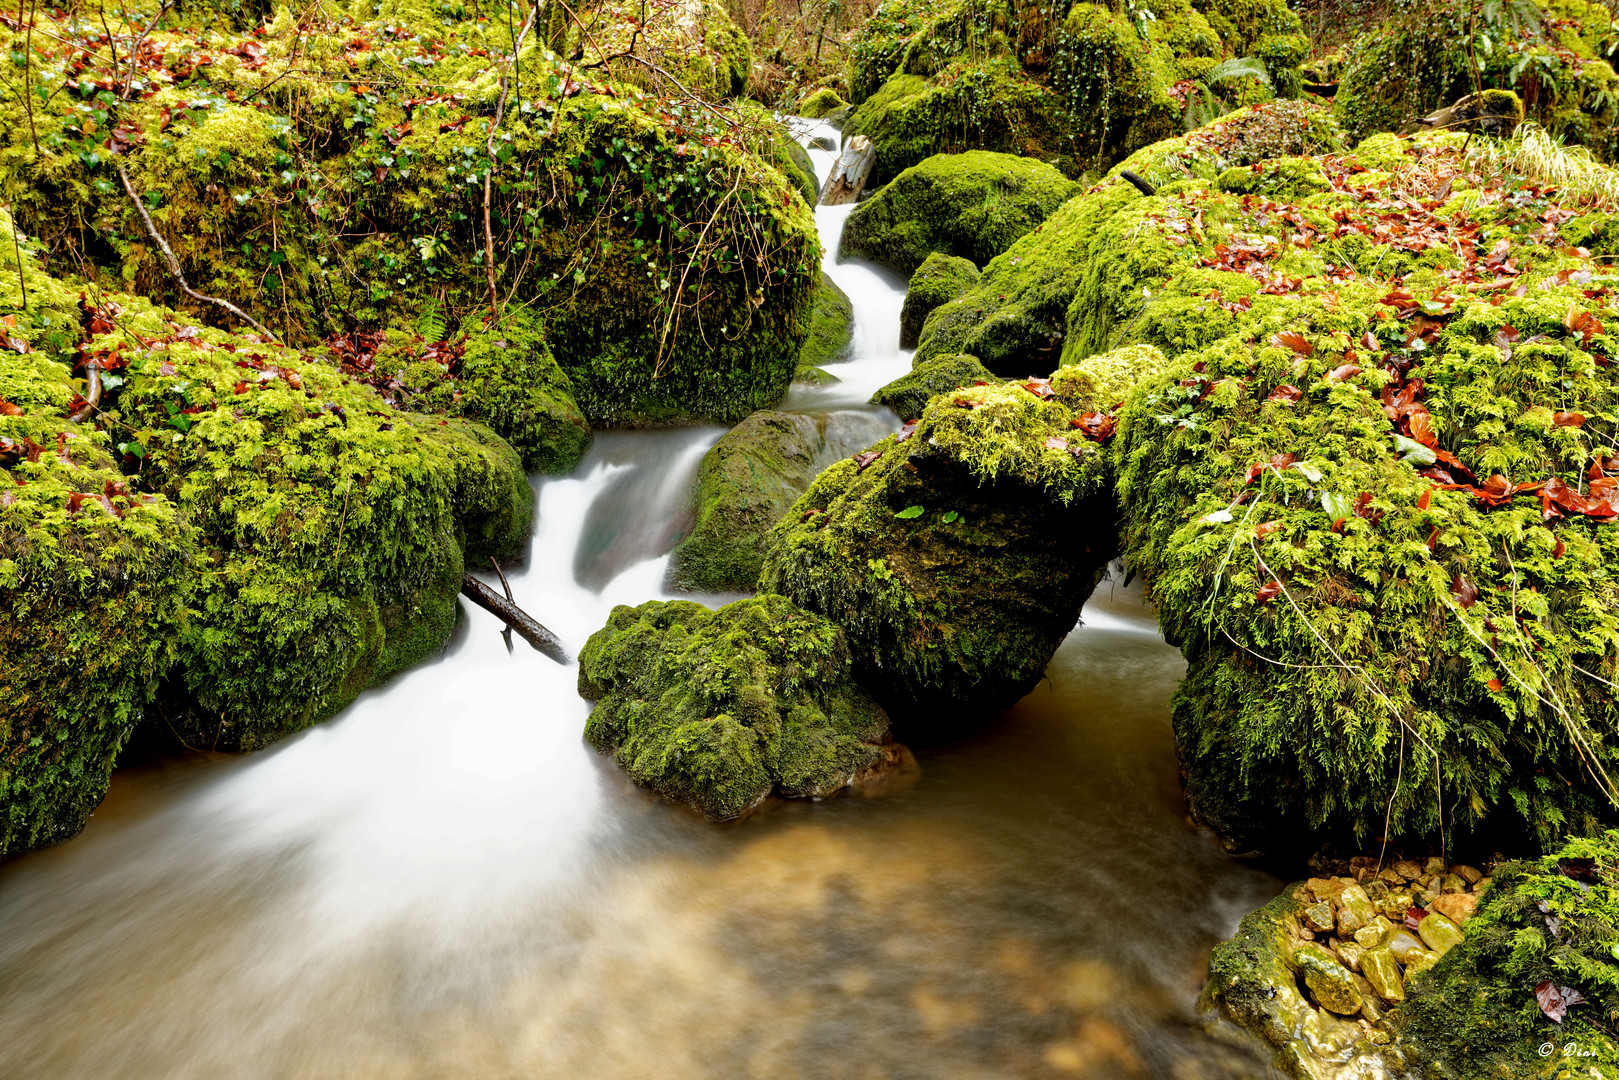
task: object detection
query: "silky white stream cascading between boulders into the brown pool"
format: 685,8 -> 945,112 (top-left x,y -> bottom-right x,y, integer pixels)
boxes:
0,120 -> 1277,1080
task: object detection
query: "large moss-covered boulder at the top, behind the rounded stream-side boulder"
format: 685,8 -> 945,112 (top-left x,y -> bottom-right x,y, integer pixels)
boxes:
845,0 -> 1308,180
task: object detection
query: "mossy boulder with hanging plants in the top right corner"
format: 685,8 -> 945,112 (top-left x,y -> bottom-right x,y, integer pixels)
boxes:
1332,0 -> 1619,160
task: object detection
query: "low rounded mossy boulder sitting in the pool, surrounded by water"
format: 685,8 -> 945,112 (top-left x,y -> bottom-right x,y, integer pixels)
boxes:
580,596 -> 894,819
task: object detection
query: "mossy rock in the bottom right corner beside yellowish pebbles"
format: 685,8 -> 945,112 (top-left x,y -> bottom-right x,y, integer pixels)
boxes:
1400,832 -> 1619,1080
